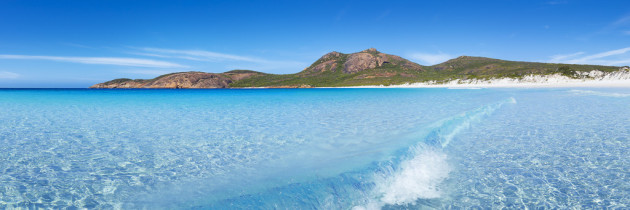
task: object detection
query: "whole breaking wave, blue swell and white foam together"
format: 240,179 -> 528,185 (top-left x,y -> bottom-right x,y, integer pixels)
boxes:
180,98 -> 516,209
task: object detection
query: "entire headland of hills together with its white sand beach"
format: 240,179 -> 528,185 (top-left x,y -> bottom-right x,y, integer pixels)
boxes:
90,48 -> 630,89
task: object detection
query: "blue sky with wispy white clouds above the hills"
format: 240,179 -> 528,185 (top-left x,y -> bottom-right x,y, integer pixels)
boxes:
0,0 -> 630,87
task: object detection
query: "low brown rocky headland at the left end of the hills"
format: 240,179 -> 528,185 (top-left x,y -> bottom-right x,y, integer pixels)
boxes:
90,70 -> 263,89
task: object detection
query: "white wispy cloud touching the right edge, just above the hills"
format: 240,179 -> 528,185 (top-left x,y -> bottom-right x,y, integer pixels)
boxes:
549,47 -> 630,65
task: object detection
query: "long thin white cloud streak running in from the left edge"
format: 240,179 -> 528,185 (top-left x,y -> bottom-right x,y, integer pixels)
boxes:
0,55 -> 187,68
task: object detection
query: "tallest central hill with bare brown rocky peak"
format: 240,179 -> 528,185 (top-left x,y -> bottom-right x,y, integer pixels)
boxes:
230,48 -> 425,87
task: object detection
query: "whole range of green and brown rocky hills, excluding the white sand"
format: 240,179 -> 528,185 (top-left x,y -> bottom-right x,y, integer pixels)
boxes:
90,48 -> 620,88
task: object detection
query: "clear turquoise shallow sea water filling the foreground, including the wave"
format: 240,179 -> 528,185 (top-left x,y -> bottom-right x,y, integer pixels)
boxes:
0,89 -> 630,209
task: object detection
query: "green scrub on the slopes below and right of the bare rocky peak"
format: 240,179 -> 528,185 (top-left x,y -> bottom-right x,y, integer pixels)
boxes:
230,54 -> 619,87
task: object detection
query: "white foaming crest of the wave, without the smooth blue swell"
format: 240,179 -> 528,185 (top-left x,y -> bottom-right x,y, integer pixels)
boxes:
353,98 -> 516,209
